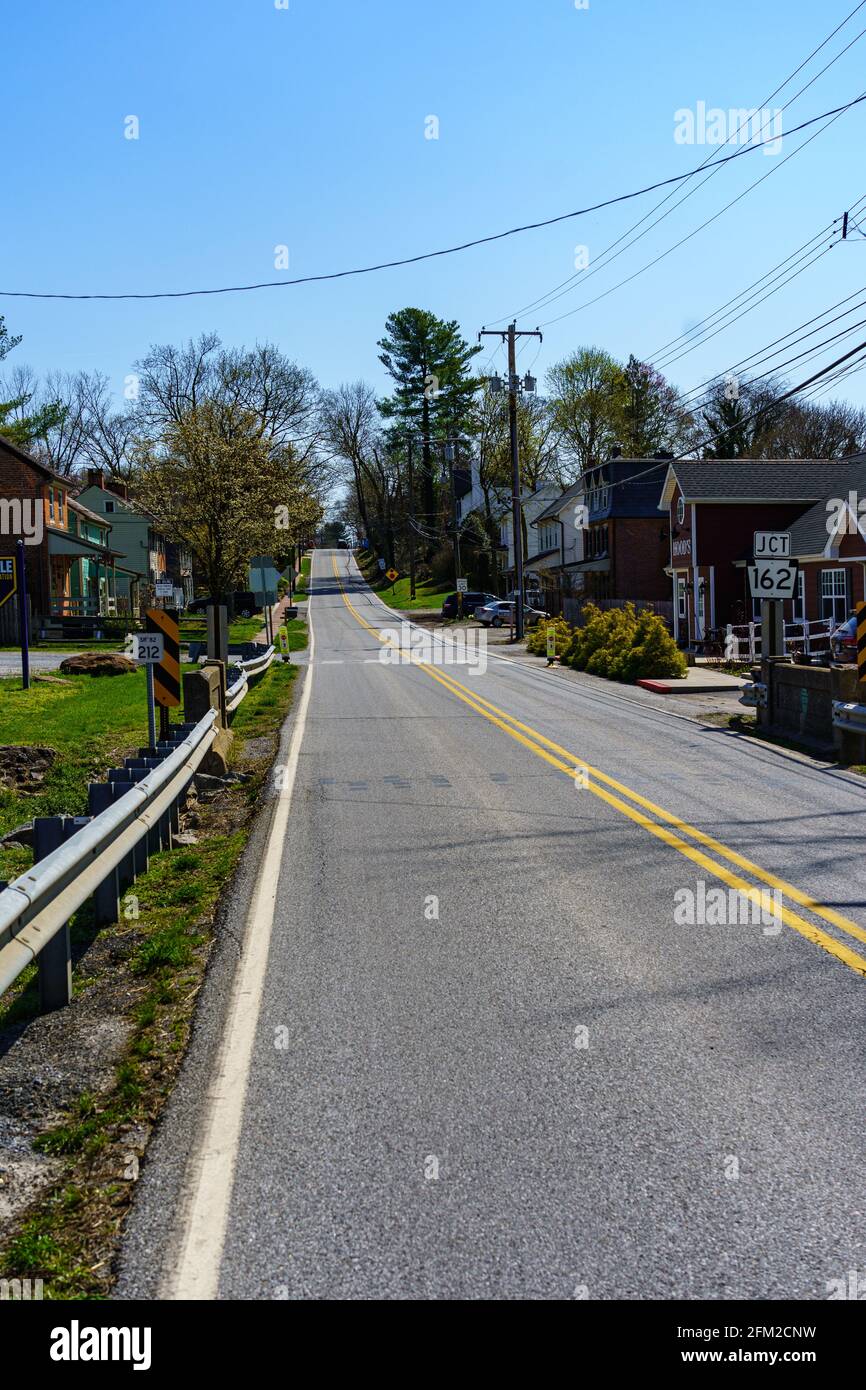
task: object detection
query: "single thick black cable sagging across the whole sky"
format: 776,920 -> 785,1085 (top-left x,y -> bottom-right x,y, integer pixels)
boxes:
0,92 -> 866,301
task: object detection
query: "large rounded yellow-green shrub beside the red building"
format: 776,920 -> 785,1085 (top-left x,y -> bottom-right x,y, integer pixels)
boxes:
563,603 -> 687,682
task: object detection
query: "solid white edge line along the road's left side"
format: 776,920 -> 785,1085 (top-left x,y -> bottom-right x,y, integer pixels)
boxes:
158,569 -> 316,1300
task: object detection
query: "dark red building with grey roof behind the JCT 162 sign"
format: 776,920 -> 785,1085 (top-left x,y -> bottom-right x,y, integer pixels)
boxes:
659,459 -> 866,646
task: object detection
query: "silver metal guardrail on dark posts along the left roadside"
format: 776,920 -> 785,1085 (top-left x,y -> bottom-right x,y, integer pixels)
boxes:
0,646 -> 277,1013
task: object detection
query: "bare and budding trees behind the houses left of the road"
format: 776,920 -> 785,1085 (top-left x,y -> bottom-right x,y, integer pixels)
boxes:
0,318 -> 325,595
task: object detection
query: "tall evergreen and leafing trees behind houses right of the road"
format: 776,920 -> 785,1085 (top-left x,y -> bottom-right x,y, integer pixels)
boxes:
322,309 -> 866,587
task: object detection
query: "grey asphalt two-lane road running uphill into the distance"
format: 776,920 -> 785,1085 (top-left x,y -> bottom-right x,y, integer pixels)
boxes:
120,552 -> 866,1300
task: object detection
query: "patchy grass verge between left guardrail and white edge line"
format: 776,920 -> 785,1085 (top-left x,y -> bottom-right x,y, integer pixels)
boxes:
0,663 -> 304,1300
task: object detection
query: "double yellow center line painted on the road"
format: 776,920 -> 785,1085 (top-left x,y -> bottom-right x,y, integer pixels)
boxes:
332,557 -> 866,976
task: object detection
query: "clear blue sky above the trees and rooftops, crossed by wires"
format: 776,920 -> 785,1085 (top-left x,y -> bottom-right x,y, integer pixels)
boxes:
0,0 -> 866,403
